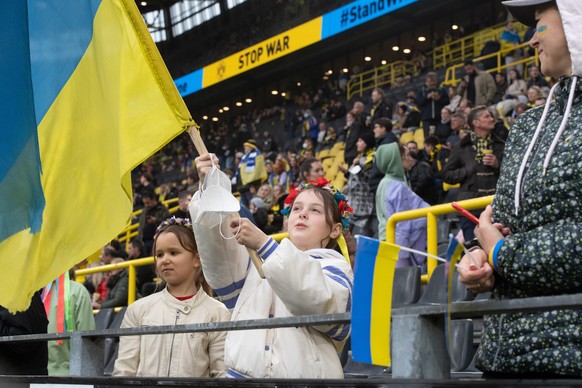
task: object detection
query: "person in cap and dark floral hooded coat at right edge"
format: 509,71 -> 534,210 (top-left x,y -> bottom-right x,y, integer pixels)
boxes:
459,0 -> 582,379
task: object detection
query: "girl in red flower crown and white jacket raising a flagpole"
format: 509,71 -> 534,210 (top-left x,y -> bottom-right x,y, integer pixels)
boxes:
190,154 -> 353,378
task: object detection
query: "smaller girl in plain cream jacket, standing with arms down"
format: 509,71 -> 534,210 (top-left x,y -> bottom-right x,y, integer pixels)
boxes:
113,217 -> 230,377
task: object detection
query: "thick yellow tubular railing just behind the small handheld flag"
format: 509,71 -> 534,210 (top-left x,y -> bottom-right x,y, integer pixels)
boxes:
386,195 -> 493,283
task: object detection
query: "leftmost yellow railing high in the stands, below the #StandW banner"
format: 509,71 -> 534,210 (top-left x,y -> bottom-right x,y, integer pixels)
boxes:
347,61 -> 418,101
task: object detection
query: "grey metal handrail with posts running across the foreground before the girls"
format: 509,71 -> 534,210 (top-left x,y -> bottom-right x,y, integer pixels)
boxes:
0,293 -> 582,385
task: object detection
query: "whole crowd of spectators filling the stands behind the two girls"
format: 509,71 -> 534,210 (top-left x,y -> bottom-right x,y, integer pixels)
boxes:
0,2 -> 580,374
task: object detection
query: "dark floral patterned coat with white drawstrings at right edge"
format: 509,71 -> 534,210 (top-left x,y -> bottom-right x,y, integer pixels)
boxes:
476,78 -> 582,376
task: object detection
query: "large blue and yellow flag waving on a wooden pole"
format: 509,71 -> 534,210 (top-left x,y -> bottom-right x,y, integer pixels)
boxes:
0,0 -> 194,310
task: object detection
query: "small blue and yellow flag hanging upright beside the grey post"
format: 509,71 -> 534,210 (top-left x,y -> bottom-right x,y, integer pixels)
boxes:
352,236 -> 400,366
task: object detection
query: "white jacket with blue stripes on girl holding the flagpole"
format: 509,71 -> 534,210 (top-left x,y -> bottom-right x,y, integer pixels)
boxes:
190,192 -> 353,378
